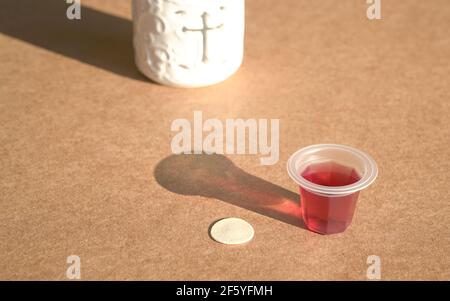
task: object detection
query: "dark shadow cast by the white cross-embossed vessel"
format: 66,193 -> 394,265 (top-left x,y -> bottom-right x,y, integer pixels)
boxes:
0,0 -> 147,81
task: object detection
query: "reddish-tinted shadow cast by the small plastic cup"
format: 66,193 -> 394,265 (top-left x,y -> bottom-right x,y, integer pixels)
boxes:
154,154 -> 306,229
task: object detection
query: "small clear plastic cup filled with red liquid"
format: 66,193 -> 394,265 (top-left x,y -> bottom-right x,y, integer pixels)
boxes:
287,144 -> 378,234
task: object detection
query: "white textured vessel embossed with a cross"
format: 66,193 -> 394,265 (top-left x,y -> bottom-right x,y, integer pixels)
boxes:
133,0 -> 245,87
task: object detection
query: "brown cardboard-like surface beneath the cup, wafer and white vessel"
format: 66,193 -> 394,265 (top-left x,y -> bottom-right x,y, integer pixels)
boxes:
0,0 -> 450,280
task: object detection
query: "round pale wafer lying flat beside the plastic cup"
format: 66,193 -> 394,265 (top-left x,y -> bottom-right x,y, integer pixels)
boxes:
210,217 -> 255,245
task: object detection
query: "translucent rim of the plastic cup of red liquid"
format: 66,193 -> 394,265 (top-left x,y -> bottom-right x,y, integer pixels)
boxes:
287,144 -> 378,195
